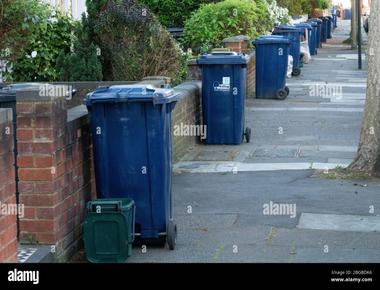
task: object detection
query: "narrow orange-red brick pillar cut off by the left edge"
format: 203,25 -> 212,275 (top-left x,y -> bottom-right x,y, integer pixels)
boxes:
0,109 -> 17,263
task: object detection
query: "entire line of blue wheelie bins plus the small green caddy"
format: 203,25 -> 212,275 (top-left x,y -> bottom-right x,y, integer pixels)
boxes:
84,13 -> 332,263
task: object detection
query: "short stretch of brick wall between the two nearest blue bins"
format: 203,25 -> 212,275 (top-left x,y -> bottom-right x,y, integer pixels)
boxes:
172,82 -> 202,161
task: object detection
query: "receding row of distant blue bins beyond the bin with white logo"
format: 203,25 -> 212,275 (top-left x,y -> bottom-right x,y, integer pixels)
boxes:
253,15 -> 336,100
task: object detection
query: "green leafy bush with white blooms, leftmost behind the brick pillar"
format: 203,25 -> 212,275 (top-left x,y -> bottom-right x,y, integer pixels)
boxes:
4,0 -> 74,82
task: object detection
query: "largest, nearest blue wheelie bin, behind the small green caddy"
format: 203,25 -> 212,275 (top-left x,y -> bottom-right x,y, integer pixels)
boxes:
85,84 -> 179,250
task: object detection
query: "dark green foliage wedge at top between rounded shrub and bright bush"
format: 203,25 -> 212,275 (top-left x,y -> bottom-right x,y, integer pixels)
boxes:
140,0 -> 220,27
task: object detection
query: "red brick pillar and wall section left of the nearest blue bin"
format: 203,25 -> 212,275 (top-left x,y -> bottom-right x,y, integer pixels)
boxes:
17,92 -> 94,259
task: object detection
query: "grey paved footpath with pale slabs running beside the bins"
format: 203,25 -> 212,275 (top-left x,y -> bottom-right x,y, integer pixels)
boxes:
129,21 -> 380,263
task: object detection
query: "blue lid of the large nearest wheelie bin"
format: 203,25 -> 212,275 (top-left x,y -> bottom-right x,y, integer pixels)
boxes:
85,84 -> 180,106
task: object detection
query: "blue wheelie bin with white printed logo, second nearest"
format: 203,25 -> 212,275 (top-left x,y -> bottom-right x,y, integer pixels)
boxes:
197,51 -> 251,145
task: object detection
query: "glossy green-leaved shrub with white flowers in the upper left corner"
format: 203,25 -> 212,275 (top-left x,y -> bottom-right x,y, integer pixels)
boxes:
5,1 -> 74,82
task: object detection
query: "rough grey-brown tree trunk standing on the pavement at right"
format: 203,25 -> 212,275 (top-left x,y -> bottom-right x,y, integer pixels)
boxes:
349,1 -> 380,176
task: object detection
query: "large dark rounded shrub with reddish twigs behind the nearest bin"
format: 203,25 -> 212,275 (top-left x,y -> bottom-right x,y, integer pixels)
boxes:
84,0 -> 181,81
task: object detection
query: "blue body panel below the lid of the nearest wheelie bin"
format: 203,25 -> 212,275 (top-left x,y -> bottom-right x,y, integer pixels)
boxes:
91,102 -> 174,238
